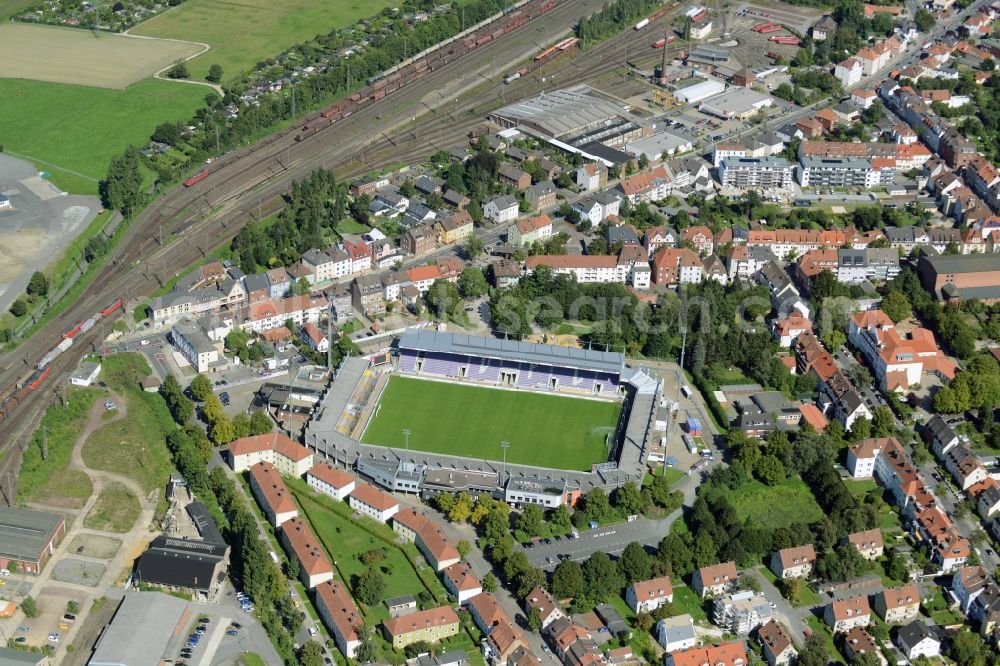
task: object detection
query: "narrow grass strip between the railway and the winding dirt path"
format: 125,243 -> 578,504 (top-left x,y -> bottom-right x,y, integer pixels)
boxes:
17,387 -> 106,502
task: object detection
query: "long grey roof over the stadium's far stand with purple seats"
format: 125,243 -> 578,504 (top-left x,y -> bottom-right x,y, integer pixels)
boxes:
399,329 -> 625,373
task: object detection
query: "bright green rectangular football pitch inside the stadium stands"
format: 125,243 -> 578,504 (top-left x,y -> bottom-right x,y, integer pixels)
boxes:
361,376 -> 621,470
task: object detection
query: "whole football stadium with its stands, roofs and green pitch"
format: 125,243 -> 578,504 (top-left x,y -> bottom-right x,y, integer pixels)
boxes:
305,329 -> 660,494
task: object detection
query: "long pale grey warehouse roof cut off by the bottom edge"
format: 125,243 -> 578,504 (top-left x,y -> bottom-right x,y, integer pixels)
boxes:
87,592 -> 187,666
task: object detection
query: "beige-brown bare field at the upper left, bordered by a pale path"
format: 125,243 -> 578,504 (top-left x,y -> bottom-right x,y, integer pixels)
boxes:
0,23 -> 205,88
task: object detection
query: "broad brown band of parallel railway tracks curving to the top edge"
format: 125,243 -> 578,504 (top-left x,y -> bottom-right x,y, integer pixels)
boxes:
0,0 -> 684,502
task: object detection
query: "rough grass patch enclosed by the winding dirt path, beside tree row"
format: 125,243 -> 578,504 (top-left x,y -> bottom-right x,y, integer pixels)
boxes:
82,378 -> 173,492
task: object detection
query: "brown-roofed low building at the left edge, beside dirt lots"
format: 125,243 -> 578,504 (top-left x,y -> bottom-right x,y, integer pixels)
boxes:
0,507 -> 66,574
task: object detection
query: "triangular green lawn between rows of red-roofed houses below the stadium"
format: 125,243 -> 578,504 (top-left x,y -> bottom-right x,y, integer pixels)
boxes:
288,481 -> 445,624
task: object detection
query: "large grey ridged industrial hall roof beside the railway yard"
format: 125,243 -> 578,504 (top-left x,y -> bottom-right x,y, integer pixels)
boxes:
492,84 -> 628,138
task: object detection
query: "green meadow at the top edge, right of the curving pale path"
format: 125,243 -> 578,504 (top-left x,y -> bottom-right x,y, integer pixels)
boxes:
132,0 -> 399,80
